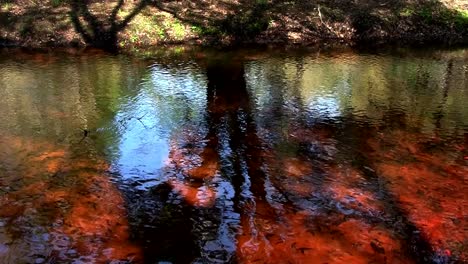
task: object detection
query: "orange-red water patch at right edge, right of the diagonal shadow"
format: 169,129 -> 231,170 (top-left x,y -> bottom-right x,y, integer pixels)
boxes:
369,131 -> 468,260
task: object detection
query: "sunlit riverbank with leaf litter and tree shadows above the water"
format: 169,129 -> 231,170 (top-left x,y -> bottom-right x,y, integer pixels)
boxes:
0,0 -> 468,50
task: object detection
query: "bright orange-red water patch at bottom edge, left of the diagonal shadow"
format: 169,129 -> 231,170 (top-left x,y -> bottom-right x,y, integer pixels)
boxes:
238,200 -> 411,263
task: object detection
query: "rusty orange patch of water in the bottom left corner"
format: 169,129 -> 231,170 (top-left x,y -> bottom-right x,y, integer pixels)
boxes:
0,136 -> 141,263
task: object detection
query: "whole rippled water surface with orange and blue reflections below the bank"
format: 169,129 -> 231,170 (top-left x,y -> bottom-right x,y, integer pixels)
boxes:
0,49 -> 468,263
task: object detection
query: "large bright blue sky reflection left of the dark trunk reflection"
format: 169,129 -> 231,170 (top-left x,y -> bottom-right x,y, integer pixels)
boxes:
113,64 -> 206,188
